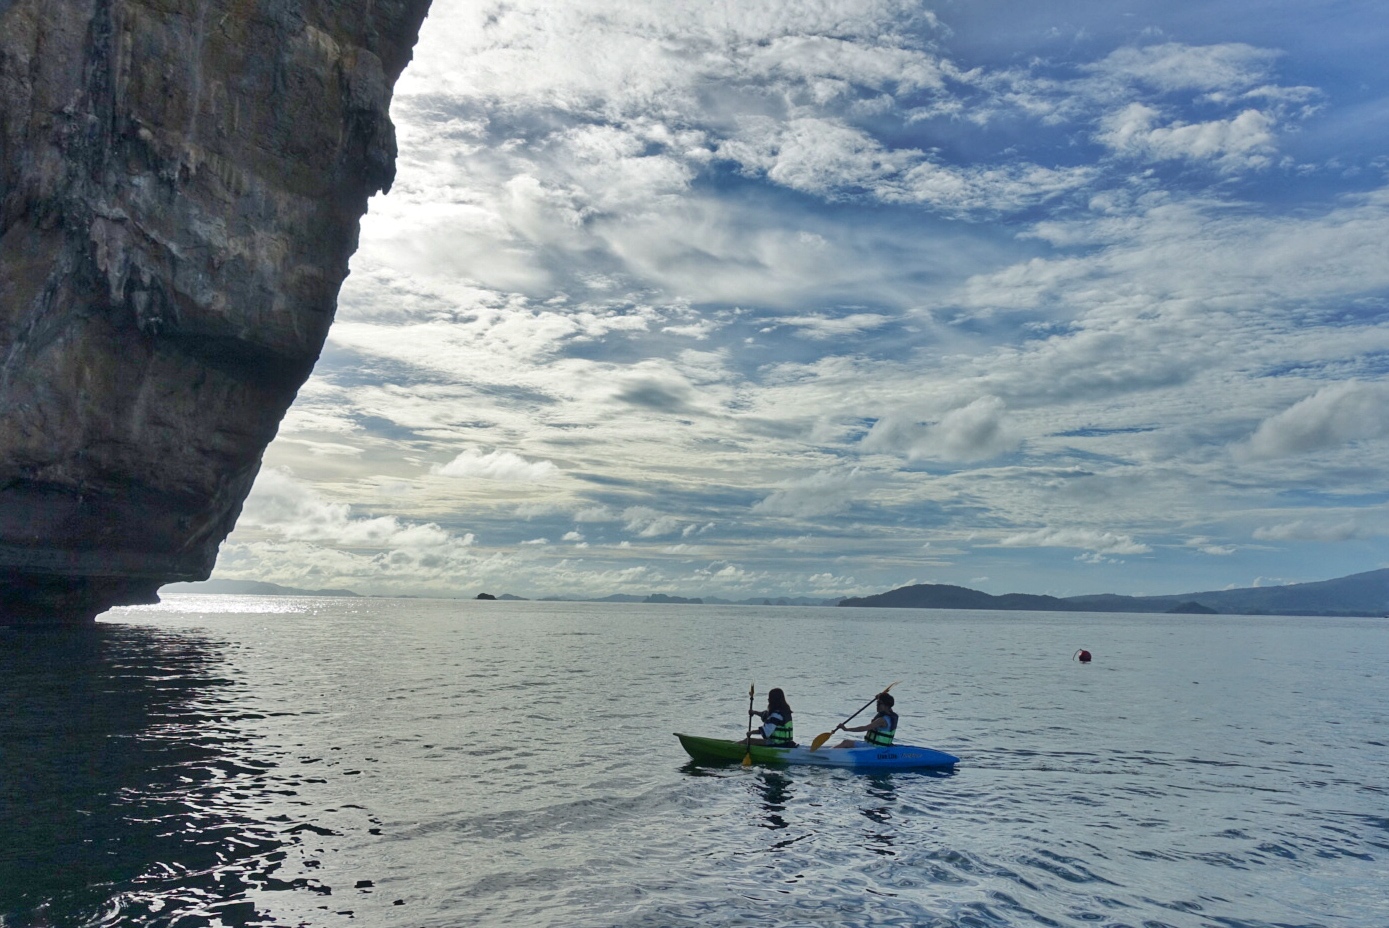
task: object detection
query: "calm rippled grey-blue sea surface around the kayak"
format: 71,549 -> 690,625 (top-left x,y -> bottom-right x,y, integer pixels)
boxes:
0,596 -> 1389,928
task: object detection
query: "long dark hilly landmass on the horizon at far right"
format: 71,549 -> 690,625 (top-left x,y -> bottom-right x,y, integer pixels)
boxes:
839,568 -> 1389,615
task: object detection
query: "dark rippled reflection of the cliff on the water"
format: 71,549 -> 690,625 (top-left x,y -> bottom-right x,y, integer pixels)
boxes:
0,624 -> 330,925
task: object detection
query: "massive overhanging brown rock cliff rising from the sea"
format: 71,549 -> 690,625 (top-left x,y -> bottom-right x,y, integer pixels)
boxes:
0,0 -> 429,624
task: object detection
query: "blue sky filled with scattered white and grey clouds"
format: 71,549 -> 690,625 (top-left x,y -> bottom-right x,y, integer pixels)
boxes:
205,0 -> 1389,600
